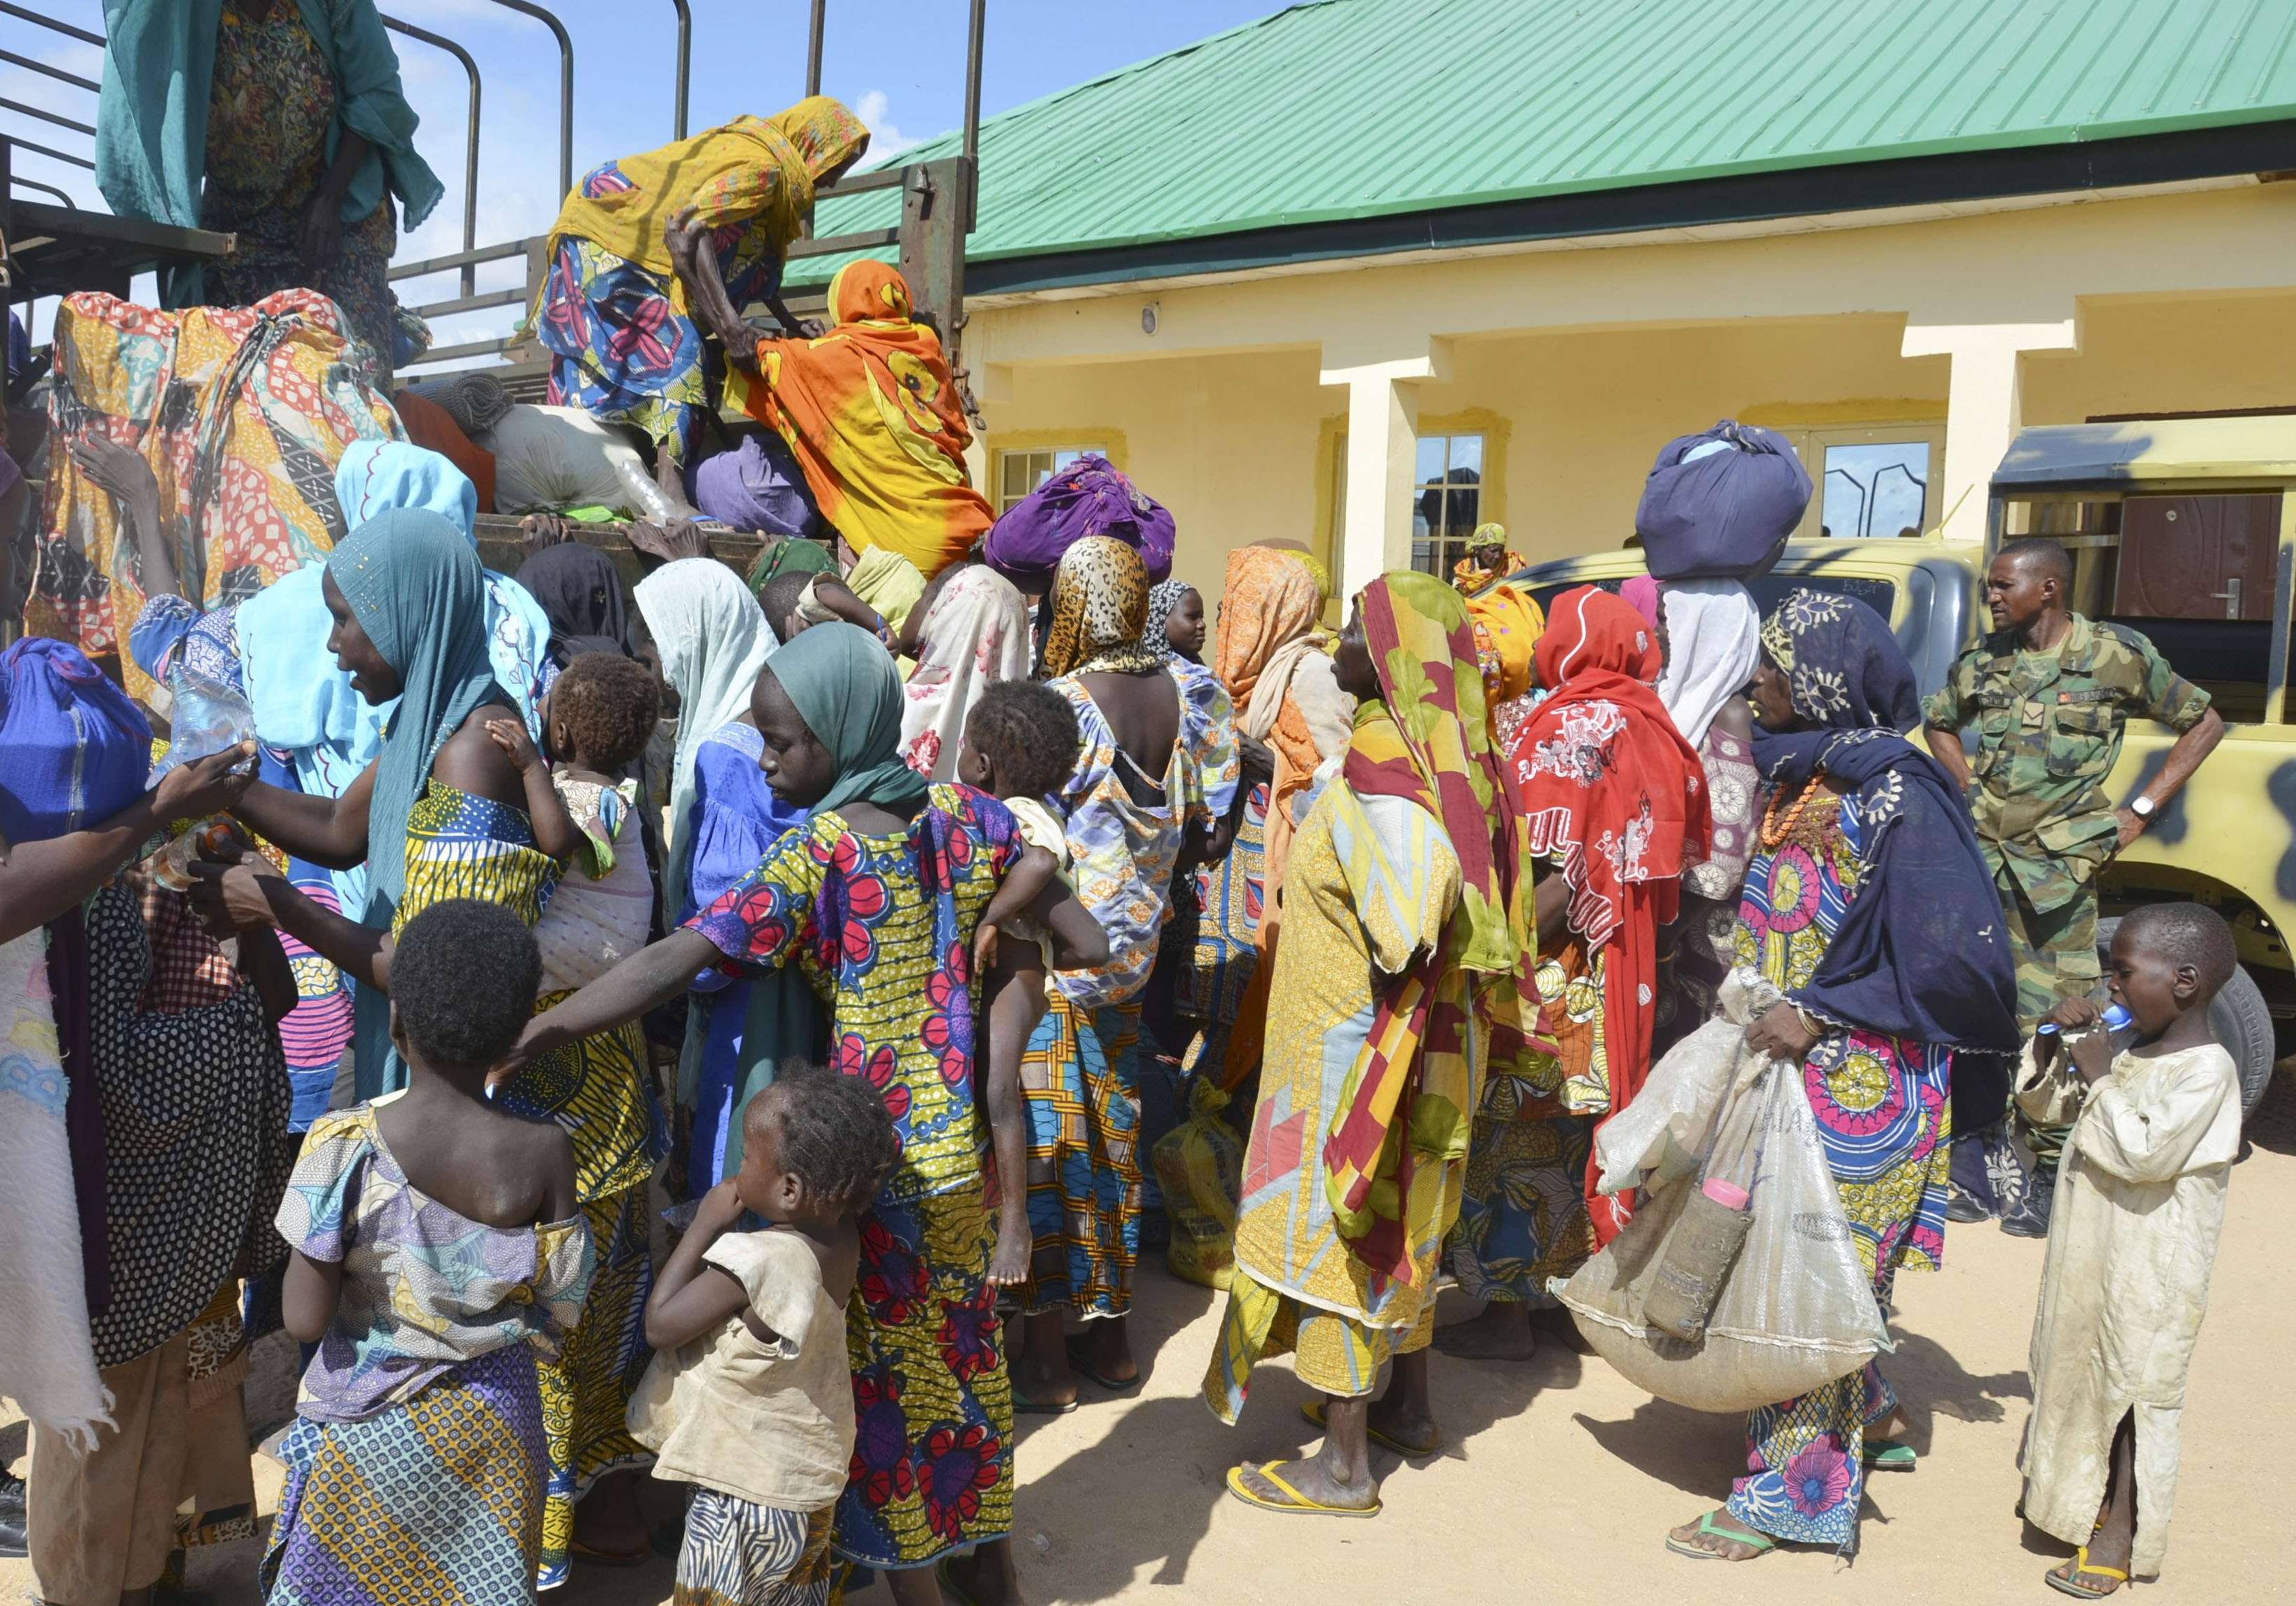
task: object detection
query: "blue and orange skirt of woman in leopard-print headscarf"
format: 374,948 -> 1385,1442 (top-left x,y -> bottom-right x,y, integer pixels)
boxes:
1017,998 -> 1141,1317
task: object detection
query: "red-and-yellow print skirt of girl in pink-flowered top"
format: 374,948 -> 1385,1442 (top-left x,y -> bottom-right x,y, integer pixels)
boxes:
831,1177 -> 1012,1569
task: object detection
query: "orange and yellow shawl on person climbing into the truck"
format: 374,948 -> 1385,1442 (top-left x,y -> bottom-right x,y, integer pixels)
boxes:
728,259 -> 994,578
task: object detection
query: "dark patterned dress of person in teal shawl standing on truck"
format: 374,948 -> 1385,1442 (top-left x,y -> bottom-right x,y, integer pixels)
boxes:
199,0 -> 400,378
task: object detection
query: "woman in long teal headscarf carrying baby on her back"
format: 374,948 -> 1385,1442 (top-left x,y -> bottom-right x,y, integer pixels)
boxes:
211,507 -> 659,1583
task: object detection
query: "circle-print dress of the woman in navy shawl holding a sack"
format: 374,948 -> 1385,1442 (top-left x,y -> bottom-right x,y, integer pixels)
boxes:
1729,792 -> 1952,1553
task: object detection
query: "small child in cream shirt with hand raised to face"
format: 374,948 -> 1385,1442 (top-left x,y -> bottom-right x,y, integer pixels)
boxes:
629,1069 -> 900,1606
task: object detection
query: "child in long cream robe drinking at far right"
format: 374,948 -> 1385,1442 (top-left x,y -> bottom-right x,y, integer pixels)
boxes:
2018,904 -> 2241,1599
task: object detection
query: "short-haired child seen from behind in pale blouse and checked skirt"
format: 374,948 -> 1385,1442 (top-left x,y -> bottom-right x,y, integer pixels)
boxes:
261,899 -> 593,1606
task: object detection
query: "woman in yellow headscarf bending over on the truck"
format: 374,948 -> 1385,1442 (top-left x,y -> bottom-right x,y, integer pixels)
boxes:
533,94 -> 868,477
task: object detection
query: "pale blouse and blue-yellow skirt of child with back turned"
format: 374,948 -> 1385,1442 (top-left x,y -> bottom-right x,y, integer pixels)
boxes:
261,1094 -> 593,1606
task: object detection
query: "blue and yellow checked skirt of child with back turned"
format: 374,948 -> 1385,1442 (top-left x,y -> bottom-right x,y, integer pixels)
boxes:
261,1345 -> 544,1606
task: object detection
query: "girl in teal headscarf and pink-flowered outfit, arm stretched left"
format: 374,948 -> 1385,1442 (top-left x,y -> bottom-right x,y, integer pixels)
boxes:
512,624 -> 1104,1606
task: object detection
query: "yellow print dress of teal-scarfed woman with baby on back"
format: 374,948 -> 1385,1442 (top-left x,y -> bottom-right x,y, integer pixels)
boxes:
393,780 -> 666,1588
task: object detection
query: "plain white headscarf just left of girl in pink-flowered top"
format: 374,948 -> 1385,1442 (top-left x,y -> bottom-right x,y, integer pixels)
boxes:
632,558 -> 781,906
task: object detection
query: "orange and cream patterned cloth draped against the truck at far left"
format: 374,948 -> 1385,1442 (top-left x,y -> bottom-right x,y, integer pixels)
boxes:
25,289 -> 400,700
